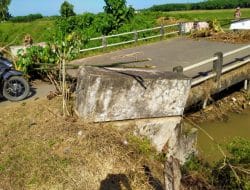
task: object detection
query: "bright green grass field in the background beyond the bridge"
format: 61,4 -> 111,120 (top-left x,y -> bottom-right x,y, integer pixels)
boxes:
0,8 -> 250,45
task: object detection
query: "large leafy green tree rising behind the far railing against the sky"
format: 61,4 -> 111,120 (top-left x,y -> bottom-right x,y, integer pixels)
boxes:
104,0 -> 134,32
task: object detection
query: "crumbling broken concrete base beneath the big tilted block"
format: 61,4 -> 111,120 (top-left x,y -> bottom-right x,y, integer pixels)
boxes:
112,116 -> 196,163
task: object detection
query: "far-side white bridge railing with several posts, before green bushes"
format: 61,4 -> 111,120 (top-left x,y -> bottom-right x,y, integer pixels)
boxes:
80,24 -> 180,52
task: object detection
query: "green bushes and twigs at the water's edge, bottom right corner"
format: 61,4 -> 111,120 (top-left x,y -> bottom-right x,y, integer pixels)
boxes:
182,138 -> 250,190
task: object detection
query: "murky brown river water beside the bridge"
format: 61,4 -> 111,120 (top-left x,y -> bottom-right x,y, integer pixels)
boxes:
197,109 -> 250,163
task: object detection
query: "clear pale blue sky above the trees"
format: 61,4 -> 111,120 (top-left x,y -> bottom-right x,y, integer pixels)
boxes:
9,0 -> 200,16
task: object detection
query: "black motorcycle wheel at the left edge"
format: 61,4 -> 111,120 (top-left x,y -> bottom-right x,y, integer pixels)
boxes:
3,76 -> 30,101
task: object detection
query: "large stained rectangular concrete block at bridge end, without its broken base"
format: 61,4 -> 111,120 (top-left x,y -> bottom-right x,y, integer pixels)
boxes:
76,67 -> 190,122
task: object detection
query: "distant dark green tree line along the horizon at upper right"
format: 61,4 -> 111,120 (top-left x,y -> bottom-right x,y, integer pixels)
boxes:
149,0 -> 250,11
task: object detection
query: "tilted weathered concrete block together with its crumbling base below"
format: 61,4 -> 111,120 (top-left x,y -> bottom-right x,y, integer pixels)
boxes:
76,67 -> 195,162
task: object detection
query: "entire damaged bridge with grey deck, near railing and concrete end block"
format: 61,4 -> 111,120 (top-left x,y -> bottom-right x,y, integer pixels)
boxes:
73,38 -> 250,161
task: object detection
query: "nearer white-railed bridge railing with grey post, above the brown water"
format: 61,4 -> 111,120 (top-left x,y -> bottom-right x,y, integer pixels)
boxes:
173,45 -> 250,86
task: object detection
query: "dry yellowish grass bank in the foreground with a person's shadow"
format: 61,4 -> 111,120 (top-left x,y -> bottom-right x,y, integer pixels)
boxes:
0,98 -> 162,190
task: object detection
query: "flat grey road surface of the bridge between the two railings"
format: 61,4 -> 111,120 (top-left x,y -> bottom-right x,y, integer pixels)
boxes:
70,37 -> 250,77
